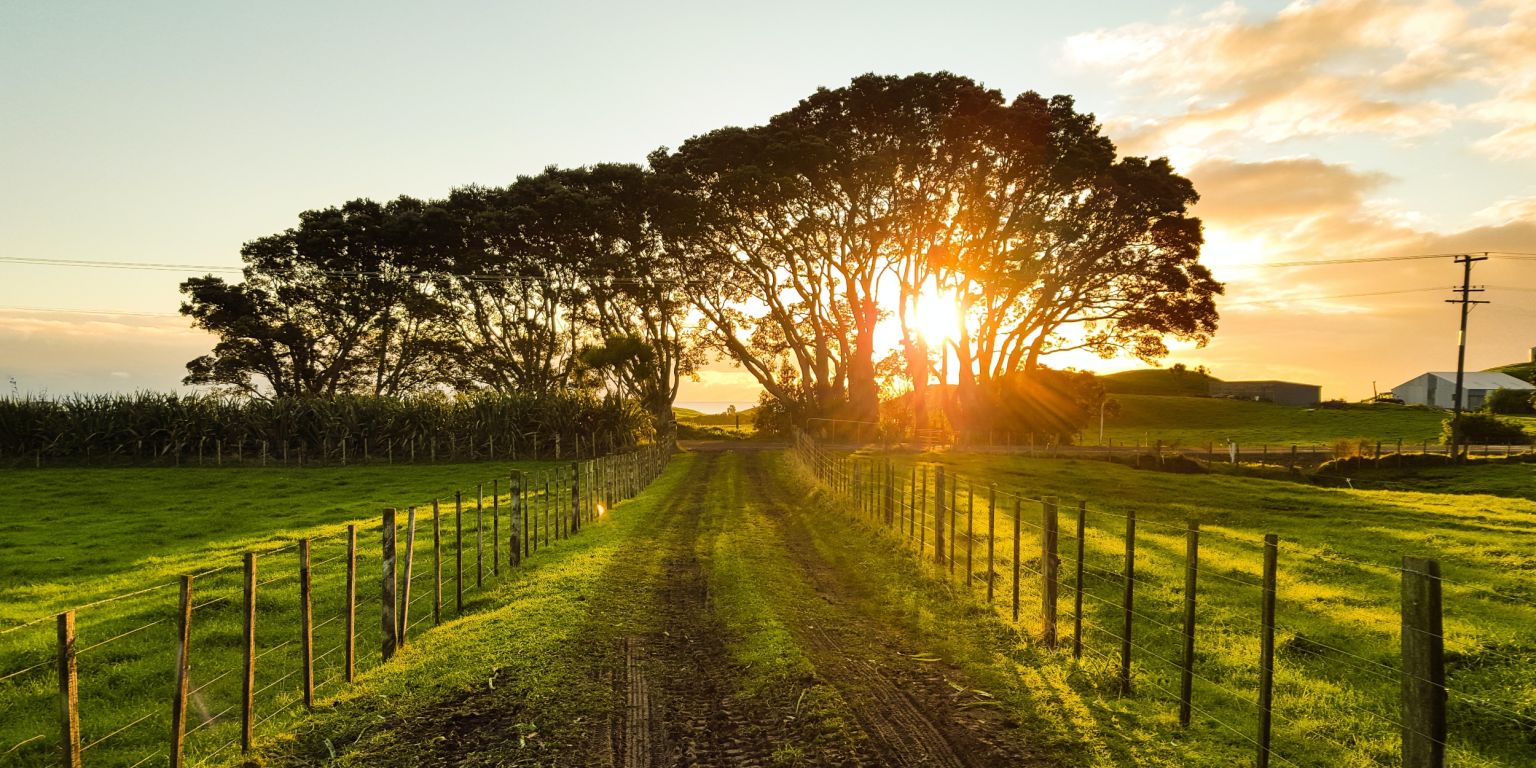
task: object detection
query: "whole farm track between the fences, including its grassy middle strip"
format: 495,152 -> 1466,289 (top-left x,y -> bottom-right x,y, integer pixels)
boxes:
276,442 -> 1049,768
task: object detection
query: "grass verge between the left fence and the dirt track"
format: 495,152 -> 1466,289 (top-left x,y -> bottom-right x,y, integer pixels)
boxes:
260,458 -> 693,766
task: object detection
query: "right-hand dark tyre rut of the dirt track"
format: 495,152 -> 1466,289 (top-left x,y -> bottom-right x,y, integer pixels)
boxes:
746,456 -> 1043,768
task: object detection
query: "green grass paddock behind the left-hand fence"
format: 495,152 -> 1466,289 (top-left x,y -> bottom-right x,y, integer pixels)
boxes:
0,464 -> 565,765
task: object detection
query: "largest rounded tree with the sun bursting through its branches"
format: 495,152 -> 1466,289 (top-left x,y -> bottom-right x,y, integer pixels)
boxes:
651,74 -> 1221,433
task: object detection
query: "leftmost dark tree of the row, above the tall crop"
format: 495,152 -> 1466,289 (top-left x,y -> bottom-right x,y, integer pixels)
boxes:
181,198 -> 447,396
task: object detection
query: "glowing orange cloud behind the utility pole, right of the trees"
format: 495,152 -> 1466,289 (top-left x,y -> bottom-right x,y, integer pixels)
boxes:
1148,157 -> 1536,398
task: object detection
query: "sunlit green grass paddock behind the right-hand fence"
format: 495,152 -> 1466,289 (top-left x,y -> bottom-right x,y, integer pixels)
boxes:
835,455 -> 1536,766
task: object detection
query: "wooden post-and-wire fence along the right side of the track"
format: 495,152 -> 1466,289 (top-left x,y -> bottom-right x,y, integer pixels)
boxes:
793,432 -> 1536,766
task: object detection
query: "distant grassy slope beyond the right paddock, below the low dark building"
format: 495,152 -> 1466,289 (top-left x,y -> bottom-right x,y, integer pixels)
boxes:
1105,395 -> 1445,452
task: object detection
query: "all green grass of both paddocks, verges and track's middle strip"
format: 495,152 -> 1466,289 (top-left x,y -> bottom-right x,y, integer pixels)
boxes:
0,436 -> 1536,768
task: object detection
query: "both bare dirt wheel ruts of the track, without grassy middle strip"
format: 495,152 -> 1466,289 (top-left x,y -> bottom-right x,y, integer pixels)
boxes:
586,445 -> 1029,768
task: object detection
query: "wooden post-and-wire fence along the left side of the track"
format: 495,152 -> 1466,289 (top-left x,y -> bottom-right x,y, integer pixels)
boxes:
0,439 -> 674,766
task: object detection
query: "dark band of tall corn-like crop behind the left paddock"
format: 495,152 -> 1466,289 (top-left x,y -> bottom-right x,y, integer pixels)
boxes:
0,392 -> 651,465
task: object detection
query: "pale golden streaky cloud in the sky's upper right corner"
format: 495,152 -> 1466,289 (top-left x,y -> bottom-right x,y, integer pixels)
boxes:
1063,0 -> 1536,163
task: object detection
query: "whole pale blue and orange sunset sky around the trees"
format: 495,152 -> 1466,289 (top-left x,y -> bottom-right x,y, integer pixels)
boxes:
0,0 -> 1536,407
